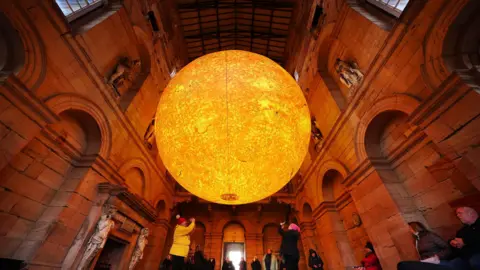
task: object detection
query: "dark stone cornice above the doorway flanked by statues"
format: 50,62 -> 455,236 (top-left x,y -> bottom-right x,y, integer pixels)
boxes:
98,182 -> 158,222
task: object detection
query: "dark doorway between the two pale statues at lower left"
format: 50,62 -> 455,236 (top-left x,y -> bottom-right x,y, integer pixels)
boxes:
94,237 -> 126,270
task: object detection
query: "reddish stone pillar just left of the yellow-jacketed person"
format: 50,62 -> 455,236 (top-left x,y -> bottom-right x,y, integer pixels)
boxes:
141,219 -> 170,269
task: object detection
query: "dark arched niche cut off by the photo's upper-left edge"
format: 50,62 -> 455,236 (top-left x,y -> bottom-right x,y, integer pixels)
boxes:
0,11 -> 25,80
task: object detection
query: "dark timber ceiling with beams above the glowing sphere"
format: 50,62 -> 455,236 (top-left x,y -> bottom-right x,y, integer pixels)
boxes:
177,0 -> 294,65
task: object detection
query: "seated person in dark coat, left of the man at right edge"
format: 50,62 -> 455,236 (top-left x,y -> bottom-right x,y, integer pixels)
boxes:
408,222 -> 452,262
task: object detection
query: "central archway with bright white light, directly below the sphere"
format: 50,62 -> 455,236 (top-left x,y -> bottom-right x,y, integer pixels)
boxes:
222,222 -> 246,270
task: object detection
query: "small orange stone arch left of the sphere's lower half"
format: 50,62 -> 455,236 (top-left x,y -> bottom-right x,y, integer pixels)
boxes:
119,158 -> 151,198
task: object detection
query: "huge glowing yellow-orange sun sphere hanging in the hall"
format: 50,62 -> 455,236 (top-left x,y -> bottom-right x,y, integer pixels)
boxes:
155,50 -> 310,204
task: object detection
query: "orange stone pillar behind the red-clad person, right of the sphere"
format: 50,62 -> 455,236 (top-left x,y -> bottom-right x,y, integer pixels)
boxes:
314,202 -> 356,270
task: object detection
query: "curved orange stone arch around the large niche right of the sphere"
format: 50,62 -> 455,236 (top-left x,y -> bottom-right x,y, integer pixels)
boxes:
355,94 -> 420,162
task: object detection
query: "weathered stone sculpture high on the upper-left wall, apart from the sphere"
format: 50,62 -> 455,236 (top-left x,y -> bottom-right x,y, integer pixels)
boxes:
105,57 -> 141,98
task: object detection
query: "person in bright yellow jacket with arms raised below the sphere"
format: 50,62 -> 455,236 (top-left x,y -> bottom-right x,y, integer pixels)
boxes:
170,215 -> 195,270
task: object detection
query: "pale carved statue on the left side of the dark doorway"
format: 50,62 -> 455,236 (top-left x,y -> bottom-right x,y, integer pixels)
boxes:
77,205 -> 117,270
